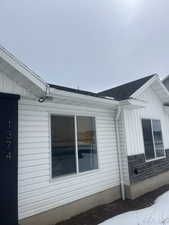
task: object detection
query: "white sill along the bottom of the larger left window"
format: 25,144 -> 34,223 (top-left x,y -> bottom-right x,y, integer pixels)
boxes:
50,168 -> 100,183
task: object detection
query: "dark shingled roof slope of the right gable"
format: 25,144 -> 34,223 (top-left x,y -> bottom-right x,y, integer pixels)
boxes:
98,74 -> 155,101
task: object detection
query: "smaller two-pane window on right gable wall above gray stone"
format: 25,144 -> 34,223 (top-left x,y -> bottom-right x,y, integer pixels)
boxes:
142,119 -> 164,160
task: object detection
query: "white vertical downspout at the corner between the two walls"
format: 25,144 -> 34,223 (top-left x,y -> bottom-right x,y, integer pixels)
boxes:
115,106 -> 126,200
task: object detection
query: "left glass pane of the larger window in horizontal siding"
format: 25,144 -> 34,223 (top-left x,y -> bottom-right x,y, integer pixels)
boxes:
51,116 -> 76,177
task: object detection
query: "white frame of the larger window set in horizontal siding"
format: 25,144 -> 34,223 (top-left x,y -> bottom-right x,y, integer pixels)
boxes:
48,112 -> 100,182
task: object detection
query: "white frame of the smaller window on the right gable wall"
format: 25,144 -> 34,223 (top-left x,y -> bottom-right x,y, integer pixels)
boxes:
141,117 -> 166,162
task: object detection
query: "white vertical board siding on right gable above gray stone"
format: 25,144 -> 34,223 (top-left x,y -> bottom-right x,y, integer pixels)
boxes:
124,87 -> 169,155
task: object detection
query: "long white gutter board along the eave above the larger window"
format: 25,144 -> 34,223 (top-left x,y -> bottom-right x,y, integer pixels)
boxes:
50,88 -> 119,108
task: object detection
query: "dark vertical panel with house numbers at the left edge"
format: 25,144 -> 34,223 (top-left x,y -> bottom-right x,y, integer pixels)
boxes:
0,93 -> 19,225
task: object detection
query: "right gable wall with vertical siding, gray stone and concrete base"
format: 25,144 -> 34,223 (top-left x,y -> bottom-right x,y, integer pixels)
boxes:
124,87 -> 169,199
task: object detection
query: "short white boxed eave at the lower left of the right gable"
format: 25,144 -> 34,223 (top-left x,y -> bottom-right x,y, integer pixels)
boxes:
120,99 -> 147,110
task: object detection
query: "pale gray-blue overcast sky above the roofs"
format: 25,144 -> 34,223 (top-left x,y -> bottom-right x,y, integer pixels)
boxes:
0,0 -> 169,91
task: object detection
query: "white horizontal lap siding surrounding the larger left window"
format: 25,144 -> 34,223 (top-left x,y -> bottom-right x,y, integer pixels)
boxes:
18,99 -> 119,219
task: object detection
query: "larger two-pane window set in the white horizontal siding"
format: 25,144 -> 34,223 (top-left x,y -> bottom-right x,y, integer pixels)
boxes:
51,115 -> 98,177
